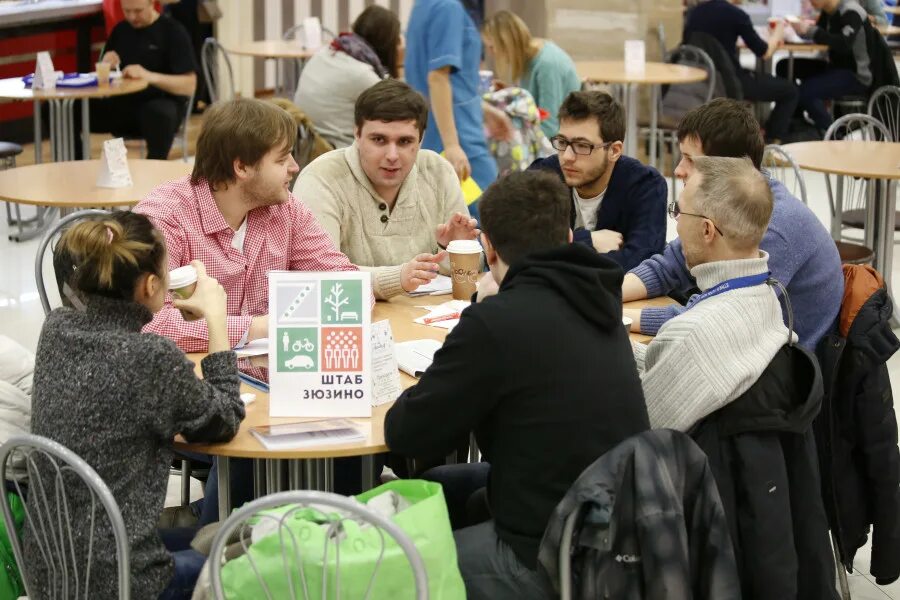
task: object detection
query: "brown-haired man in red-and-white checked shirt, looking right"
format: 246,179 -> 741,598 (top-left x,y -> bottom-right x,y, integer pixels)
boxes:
135,99 -> 357,352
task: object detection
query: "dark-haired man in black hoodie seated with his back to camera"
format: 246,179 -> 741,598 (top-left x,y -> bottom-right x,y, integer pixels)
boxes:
384,171 -> 648,599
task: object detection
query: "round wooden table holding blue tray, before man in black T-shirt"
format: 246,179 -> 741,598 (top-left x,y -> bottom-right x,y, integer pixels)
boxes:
0,77 -> 148,163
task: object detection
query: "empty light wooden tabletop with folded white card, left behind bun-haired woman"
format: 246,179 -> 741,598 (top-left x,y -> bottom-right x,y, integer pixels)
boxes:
0,158 -> 192,208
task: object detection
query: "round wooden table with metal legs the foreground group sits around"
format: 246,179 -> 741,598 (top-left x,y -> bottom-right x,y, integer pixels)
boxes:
175,295 -> 674,519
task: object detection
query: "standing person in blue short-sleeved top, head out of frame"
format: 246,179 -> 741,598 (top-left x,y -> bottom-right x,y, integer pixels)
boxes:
404,0 -> 512,209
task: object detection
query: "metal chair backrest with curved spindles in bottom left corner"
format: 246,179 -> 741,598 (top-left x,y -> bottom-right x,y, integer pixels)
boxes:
0,435 -> 131,600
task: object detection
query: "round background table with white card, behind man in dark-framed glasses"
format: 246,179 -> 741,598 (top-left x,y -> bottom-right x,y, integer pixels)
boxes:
575,60 -> 707,164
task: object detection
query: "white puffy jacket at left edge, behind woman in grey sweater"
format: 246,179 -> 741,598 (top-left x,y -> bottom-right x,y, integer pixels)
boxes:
0,335 -> 34,480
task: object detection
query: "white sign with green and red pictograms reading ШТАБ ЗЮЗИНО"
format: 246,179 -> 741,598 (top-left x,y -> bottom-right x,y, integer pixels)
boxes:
269,271 -> 372,417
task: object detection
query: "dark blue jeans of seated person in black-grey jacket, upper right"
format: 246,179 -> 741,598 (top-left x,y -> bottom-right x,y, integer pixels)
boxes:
775,58 -> 868,132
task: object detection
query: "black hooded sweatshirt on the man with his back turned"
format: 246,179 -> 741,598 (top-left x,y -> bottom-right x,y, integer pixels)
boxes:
384,244 -> 649,569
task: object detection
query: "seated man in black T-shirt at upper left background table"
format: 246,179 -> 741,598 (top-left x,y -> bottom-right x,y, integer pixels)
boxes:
85,0 -> 197,160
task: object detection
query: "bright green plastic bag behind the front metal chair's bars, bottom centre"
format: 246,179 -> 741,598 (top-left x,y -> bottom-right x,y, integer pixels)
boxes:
222,480 -> 466,600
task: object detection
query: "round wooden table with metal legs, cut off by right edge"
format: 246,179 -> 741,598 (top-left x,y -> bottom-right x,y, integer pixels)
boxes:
784,140 -> 900,291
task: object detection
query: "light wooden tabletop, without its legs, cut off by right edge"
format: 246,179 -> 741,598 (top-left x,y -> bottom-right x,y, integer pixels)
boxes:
783,140 -> 900,179
